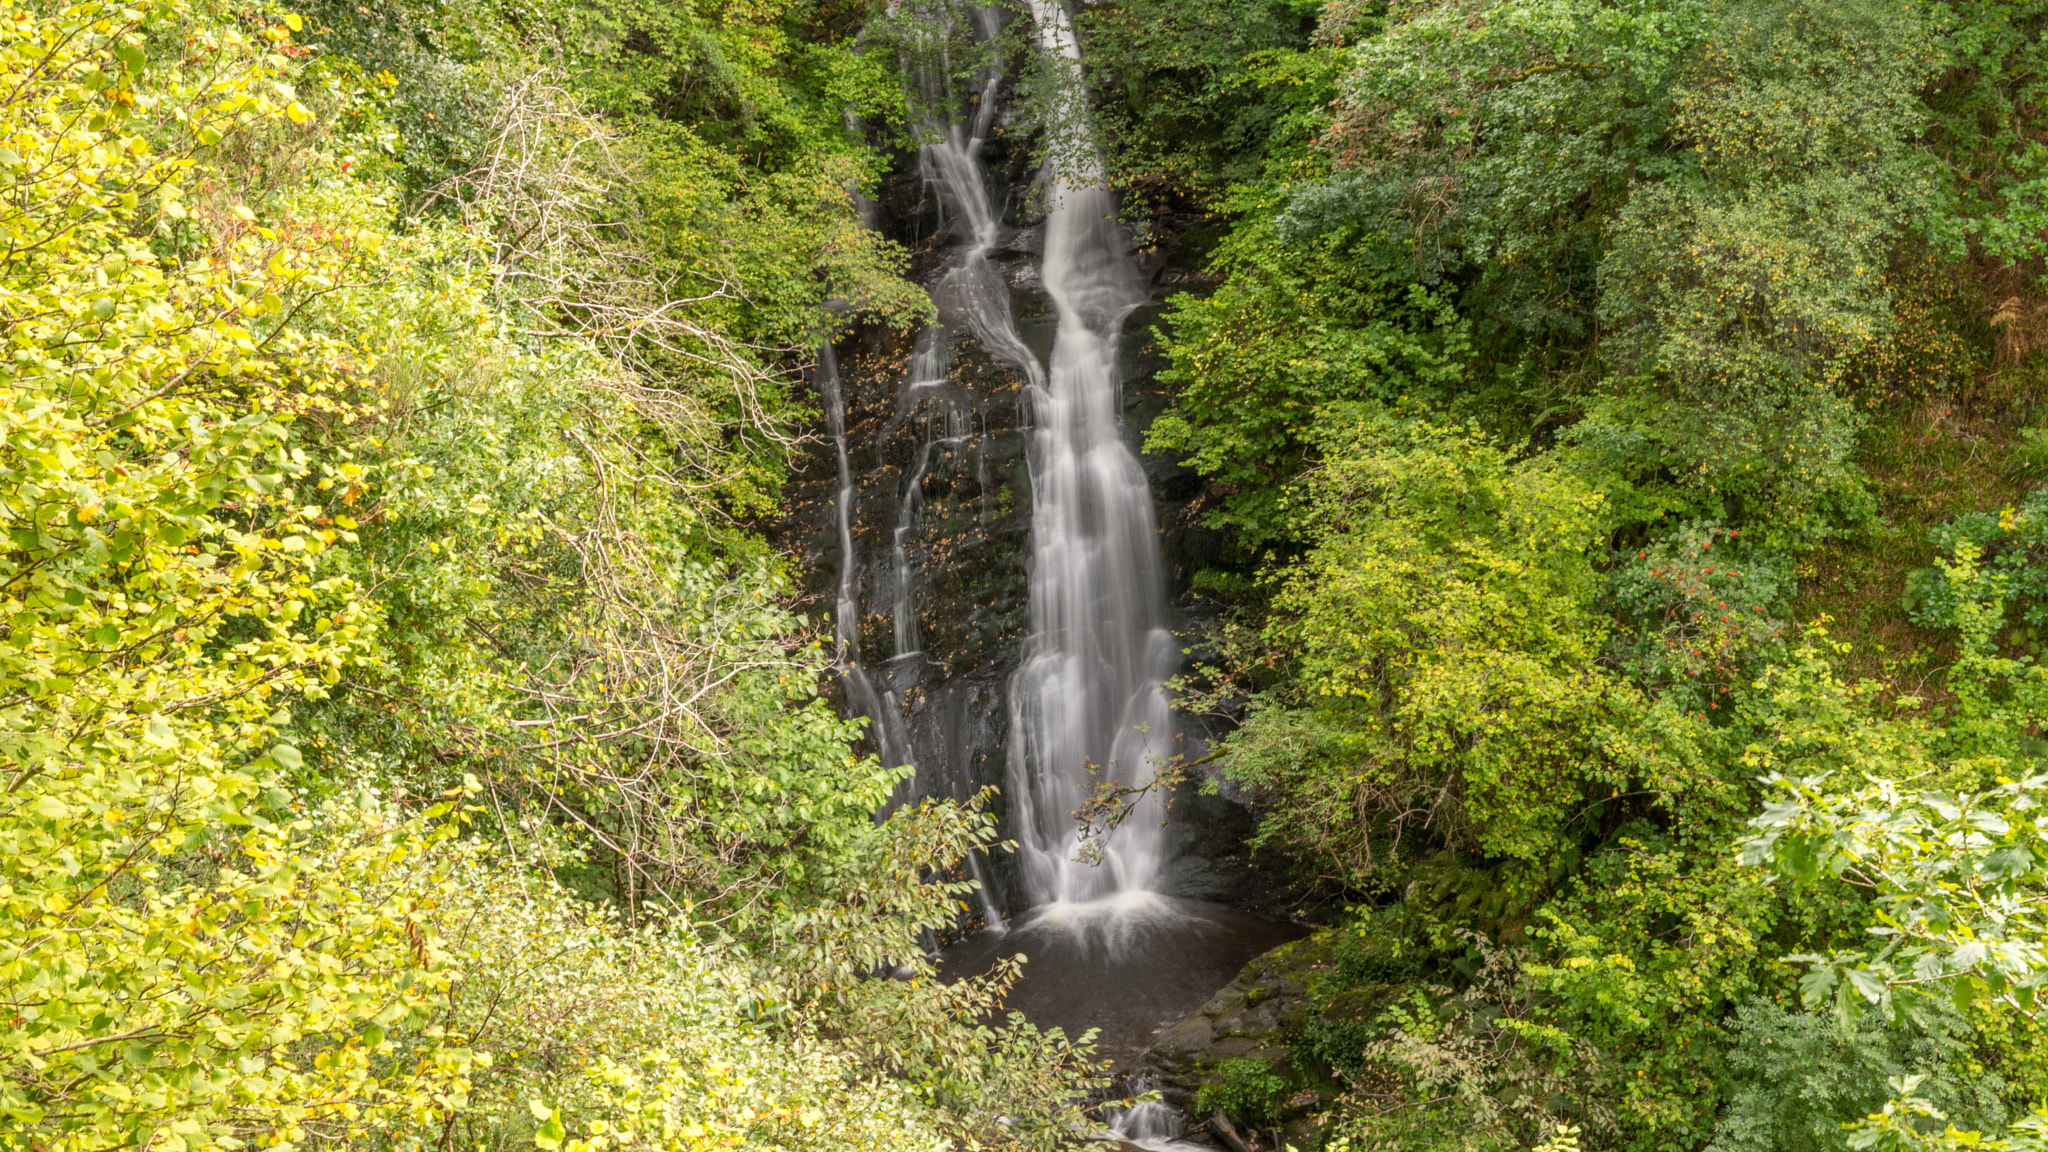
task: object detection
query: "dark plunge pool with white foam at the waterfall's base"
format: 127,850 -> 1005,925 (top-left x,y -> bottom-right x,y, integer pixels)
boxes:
940,894 -> 1309,1066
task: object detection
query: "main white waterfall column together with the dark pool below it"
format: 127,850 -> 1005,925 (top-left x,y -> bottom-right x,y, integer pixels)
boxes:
946,0 -> 1298,1074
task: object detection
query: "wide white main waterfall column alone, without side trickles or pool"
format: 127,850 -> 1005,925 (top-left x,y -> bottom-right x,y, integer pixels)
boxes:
1010,0 -> 1178,908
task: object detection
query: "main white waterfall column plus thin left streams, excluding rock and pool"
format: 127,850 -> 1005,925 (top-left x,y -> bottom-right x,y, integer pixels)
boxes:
819,0 -> 1178,927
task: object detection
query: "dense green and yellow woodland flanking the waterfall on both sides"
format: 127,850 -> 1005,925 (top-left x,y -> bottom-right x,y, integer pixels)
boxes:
12,0 -> 2048,1152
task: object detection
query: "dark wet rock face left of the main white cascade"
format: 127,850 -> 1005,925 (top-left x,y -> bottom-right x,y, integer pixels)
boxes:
770,125 -> 1051,910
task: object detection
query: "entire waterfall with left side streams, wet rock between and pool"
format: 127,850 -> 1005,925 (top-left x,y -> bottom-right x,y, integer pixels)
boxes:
839,0 -> 1300,1074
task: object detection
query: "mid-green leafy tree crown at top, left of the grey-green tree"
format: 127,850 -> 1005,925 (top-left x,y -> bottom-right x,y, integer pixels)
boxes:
1290,0 -> 1708,342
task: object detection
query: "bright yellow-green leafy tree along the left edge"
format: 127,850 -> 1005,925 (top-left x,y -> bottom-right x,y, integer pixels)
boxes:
0,0 -> 481,1150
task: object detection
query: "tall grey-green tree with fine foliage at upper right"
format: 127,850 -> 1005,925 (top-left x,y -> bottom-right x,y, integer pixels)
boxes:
1597,6 -> 1939,545
